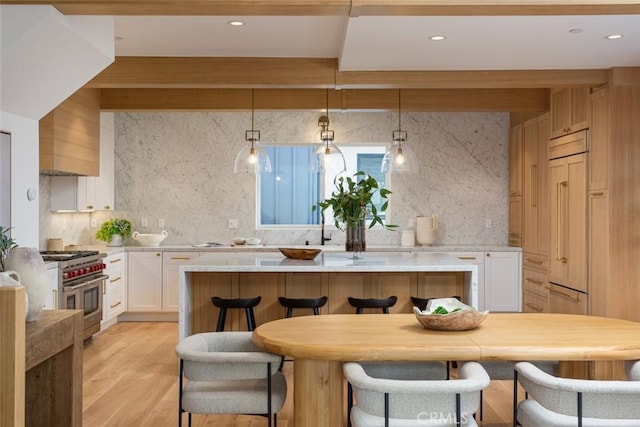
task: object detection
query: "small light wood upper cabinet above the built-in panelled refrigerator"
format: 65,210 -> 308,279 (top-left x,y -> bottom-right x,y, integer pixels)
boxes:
550,87 -> 591,138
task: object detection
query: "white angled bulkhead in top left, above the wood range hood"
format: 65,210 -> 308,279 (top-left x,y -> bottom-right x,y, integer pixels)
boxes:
0,5 -> 114,122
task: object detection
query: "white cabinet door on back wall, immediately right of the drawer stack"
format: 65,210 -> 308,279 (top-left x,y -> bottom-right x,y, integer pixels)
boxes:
127,252 -> 162,312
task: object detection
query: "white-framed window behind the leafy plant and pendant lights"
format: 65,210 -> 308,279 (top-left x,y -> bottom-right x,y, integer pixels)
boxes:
257,144 -> 386,228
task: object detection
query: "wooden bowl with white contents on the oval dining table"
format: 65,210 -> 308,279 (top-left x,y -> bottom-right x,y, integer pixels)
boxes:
413,298 -> 489,331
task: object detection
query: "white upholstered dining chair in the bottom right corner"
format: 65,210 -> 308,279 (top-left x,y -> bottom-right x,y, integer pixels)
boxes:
516,362 -> 640,427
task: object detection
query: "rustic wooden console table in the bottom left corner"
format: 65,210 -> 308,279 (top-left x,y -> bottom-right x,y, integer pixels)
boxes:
0,287 -> 84,427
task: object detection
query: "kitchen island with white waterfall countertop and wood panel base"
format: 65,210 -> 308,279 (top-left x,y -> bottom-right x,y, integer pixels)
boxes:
178,252 -> 478,339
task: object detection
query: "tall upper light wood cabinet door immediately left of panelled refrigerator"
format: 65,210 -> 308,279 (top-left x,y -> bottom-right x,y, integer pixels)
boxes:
522,114 -> 549,254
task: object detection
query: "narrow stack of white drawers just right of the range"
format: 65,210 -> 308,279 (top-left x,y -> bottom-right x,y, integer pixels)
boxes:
101,252 -> 127,329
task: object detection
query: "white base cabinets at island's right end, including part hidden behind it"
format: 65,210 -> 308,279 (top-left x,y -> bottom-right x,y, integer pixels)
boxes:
448,251 -> 522,311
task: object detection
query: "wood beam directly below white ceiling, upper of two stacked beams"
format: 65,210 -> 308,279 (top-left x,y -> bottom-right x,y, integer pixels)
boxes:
86,57 -> 609,89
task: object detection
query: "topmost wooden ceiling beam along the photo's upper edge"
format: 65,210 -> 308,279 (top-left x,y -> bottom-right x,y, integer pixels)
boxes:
2,0 -> 640,17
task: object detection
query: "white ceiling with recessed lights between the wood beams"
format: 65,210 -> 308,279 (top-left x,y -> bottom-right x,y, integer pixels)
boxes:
115,15 -> 640,71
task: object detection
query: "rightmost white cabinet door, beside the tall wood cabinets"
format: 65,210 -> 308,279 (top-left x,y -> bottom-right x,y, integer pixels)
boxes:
484,252 -> 522,311
